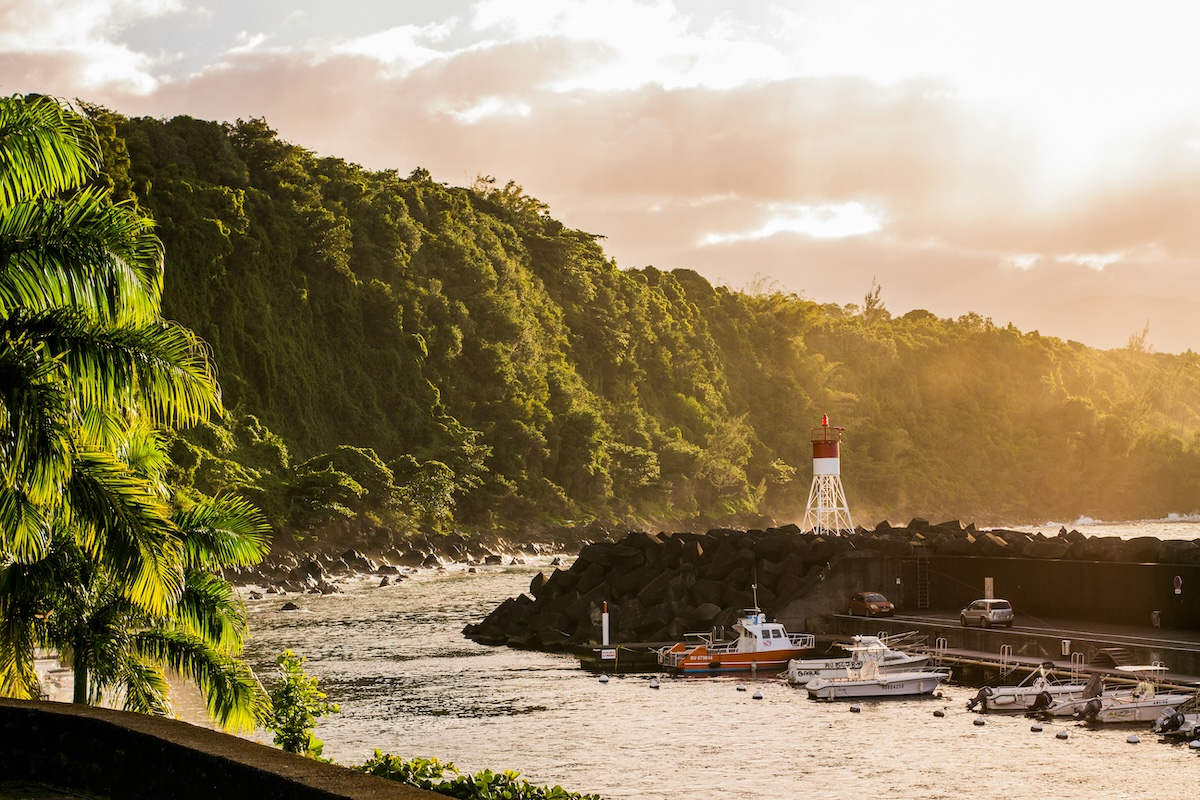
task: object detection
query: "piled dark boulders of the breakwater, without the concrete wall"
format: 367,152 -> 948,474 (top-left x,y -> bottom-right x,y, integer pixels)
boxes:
463,518 -> 1200,650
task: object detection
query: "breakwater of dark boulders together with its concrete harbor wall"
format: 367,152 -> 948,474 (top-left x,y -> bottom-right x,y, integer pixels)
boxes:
464,519 -> 1200,650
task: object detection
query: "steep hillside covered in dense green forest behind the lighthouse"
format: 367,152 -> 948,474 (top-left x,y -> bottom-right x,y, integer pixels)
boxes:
89,108 -> 1200,533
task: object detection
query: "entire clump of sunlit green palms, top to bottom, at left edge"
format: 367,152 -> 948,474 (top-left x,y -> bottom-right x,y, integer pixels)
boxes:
0,90 -> 265,727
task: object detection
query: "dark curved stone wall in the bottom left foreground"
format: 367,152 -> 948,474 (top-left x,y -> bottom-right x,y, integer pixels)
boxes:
0,699 -> 443,800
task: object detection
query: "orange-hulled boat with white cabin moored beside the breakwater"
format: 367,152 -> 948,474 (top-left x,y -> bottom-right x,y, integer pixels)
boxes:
658,607 -> 816,674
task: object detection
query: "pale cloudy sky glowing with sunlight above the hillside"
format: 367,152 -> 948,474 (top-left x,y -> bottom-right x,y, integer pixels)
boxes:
0,0 -> 1200,353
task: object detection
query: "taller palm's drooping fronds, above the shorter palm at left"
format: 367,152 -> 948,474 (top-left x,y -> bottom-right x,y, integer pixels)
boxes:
0,96 -> 220,618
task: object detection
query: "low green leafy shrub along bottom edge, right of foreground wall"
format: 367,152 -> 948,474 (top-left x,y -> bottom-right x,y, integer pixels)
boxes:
358,750 -> 600,800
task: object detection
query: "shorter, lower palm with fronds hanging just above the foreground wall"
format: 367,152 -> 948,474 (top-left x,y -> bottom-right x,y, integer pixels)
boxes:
0,497 -> 269,730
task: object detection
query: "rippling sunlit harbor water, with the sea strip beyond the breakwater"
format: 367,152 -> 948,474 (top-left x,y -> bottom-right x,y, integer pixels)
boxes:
236,521 -> 1200,800
